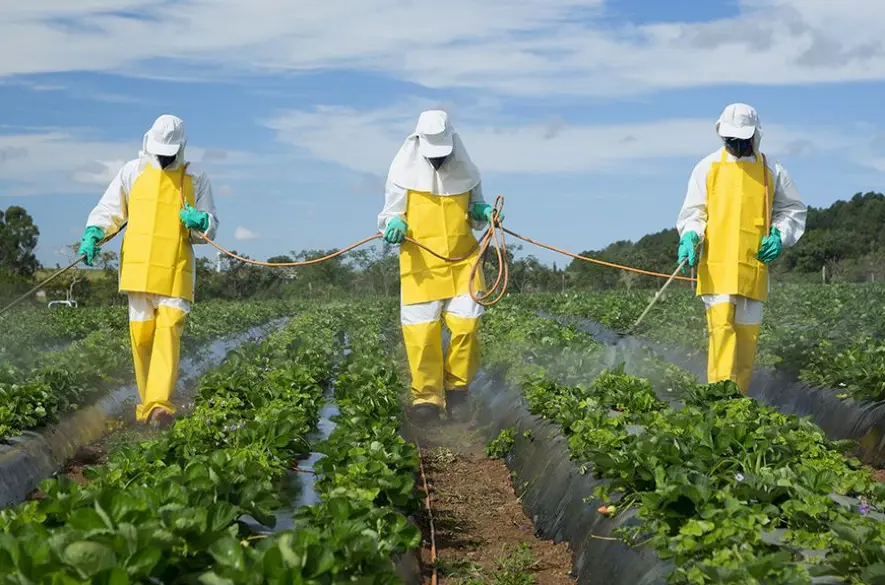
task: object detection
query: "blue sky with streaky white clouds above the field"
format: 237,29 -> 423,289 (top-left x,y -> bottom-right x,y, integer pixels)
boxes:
0,0 -> 885,265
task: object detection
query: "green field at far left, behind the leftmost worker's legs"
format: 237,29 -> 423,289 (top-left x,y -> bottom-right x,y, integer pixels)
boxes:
0,301 -> 294,439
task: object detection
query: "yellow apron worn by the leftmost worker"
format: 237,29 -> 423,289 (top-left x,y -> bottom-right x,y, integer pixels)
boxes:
120,165 -> 194,301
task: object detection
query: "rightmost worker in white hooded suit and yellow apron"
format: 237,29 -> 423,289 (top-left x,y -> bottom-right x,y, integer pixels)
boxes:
677,104 -> 806,394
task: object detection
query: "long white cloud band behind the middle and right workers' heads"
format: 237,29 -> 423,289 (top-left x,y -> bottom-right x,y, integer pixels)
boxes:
266,101 -> 852,176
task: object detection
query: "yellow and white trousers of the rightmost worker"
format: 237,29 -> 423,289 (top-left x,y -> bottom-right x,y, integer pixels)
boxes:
705,295 -> 762,395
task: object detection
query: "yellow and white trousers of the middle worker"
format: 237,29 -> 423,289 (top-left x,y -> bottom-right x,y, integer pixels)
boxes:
401,295 -> 482,408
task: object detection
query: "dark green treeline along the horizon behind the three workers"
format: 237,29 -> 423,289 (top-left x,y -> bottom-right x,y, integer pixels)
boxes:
0,192 -> 885,304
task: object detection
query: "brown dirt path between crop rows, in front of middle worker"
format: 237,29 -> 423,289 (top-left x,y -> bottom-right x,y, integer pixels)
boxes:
408,412 -> 574,585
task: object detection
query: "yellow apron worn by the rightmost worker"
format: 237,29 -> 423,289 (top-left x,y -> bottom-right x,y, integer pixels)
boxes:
697,148 -> 771,301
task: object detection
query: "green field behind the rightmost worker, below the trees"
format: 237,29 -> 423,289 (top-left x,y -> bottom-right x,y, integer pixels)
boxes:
518,285 -> 885,401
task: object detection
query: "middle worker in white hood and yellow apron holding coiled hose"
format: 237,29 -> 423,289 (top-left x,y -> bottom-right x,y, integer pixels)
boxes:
378,110 -> 503,420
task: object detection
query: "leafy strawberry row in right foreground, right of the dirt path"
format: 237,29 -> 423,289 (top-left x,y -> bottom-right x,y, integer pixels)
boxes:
484,307 -> 885,585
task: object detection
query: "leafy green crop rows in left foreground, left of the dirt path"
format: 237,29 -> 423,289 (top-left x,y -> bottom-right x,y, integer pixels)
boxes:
0,305 -> 420,585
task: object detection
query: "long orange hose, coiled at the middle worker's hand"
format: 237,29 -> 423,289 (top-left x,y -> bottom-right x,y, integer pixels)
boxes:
181,168 -> 697,307
